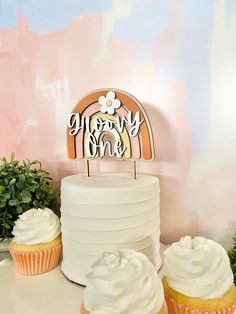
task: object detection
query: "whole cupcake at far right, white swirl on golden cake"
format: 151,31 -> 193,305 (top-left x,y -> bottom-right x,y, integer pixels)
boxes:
163,236 -> 236,314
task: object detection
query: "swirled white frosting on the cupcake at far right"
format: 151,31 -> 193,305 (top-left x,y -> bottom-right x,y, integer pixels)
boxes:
163,236 -> 233,300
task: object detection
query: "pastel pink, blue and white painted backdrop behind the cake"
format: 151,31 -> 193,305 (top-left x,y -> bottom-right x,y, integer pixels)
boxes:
0,0 -> 236,246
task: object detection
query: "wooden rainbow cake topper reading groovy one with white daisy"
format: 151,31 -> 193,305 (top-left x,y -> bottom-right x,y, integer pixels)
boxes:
67,88 -> 154,178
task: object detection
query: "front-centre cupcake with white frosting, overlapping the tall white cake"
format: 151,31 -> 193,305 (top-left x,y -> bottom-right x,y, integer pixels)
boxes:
81,250 -> 164,314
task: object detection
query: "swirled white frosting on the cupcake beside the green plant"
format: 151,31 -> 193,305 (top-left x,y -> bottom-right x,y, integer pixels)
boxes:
12,208 -> 61,245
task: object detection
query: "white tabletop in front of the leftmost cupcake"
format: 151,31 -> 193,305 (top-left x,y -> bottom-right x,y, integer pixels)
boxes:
0,246 -> 164,314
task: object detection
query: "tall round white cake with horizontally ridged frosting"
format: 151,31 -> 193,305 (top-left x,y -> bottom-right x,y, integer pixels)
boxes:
61,173 -> 161,285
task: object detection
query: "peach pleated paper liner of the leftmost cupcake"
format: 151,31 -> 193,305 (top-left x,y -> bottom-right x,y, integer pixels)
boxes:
9,244 -> 62,275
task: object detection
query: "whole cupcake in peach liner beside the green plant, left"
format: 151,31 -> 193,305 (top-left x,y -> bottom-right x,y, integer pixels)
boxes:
8,208 -> 62,275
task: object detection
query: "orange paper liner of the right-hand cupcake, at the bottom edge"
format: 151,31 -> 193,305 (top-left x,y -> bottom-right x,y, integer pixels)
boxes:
165,294 -> 236,314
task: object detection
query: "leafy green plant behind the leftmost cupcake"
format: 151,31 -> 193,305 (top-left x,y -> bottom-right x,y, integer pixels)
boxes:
0,153 -> 57,240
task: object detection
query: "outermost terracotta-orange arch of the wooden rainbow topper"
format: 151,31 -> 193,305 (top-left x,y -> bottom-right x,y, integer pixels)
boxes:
67,88 -> 154,160
